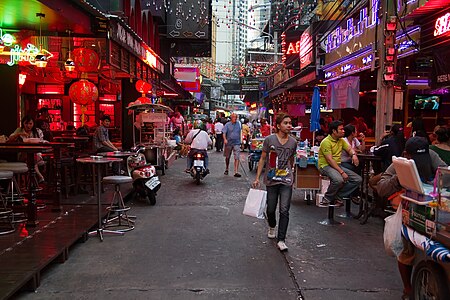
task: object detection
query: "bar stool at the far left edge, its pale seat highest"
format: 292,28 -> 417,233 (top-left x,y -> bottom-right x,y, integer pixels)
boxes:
0,162 -> 28,223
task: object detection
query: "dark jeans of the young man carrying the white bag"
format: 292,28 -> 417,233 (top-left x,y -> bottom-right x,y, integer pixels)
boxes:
266,184 -> 292,241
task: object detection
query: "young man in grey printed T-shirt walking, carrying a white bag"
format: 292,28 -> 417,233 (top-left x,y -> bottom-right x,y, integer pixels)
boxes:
252,113 -> 297,251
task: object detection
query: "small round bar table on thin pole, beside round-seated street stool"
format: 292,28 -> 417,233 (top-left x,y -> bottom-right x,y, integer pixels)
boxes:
77,156 -> 124,242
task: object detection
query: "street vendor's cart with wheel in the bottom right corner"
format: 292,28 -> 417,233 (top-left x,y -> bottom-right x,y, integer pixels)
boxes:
393,157 -> 450,299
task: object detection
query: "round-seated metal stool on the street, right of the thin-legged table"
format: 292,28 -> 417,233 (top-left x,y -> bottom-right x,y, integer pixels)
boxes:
103,175 -> 134,232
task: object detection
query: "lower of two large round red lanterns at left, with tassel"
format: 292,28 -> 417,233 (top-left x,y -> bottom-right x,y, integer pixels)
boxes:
69,79 -> 98,126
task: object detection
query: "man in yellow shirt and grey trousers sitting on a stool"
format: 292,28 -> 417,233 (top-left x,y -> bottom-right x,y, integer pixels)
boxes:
319,121 -> 362,206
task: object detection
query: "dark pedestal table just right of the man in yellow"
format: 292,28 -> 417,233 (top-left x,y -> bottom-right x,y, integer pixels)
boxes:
355,153 -> 383,224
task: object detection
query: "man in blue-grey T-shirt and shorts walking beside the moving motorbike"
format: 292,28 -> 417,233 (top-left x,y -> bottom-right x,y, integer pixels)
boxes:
222,113 -> 242,177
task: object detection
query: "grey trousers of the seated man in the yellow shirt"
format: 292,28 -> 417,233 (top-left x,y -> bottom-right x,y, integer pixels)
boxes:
320,165 -> 362,203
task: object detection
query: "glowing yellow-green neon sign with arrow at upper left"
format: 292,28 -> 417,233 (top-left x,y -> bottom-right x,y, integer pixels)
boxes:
0,28 -> 53,66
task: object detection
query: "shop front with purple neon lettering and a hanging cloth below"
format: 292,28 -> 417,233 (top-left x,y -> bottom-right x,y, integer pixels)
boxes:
322,0 -> 381,135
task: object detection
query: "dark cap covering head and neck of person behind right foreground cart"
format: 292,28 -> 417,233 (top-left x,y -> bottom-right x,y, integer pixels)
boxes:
405,136 -> 434,182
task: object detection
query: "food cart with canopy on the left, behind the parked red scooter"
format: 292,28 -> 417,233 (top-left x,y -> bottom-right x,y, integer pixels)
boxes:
127,103 -> 176,175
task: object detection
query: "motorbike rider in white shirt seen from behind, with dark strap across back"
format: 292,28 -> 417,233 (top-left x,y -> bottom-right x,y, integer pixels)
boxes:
184,120 -> 212,174
